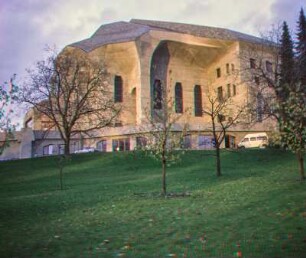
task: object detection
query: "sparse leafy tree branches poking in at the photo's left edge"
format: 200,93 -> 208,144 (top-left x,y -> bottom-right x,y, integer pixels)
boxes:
0,75 -> 18,155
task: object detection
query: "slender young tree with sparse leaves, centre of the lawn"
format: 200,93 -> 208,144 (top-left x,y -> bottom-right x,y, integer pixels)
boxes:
142,82 -> 187,196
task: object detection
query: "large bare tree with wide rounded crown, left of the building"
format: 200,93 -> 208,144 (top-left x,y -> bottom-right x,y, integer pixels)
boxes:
21,50 -> 120,155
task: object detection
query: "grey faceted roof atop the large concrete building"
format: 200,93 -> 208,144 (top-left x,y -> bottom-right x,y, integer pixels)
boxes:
70,19 -> 263,52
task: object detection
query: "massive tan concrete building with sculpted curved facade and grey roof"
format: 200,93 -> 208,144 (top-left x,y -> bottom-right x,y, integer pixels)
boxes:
0,19 -> 275,159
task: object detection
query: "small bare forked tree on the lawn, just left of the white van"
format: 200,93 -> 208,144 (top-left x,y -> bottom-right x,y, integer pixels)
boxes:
203,91 -> 247,177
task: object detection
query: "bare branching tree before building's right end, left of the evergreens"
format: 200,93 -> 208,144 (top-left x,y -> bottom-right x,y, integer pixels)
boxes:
239,25 -> 282,121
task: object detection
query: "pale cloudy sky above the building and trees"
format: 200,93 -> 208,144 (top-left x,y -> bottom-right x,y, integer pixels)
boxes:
0,0 -> 306,124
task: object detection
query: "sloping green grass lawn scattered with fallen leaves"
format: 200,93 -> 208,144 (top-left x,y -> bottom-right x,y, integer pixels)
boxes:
0,150 -> 306,258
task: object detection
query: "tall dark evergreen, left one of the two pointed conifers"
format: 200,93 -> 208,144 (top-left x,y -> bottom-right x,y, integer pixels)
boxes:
277,21 -> 295,102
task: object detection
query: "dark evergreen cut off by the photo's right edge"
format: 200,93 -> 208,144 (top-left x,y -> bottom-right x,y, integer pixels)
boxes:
296,8 -> 306,88
